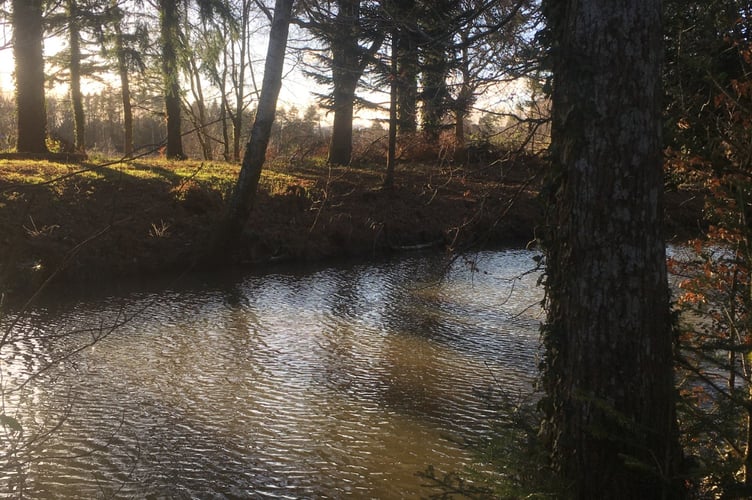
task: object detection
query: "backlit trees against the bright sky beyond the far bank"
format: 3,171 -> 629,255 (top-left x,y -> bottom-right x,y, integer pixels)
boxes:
0,0 -> 540,164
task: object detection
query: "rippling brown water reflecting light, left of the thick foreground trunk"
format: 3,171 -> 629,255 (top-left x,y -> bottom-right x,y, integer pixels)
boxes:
0,251 -> 541,498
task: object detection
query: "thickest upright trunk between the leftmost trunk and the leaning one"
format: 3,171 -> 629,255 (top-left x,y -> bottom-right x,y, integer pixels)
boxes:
159,0 -> 185,159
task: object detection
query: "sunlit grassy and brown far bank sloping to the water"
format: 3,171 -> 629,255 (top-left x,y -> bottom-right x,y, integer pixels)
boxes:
0,154 -> 703,295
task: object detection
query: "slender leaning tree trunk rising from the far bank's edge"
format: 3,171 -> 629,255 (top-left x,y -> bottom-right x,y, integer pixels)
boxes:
214,0 -> 293,246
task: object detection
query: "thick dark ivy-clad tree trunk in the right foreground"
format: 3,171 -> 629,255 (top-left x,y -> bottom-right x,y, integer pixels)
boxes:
543,0 -> 679,499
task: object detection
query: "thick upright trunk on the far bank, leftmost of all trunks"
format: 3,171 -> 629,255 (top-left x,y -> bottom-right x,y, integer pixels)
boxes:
13,0 -> 47,153
